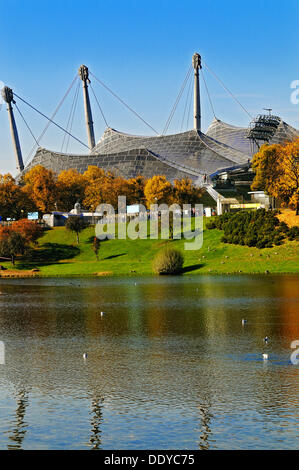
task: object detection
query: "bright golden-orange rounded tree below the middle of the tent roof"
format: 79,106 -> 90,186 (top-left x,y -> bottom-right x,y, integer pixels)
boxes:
144,175 -> 173,208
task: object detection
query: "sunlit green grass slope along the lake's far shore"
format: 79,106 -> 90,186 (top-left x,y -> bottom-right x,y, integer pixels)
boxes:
1,219 -> 299,276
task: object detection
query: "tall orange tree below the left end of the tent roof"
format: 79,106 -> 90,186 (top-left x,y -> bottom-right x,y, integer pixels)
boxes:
24,165 -> 57,214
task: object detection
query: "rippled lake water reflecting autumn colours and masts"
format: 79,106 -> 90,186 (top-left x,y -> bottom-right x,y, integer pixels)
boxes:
0,276 -> 299,449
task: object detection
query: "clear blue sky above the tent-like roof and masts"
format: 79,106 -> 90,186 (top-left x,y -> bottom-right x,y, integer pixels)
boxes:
0,0 -> 299,175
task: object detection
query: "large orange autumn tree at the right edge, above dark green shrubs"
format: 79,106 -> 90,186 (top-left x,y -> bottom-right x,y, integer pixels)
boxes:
251,138 -> 299,215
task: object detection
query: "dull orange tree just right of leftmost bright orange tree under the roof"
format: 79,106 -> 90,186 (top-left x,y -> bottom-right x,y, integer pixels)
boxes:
57,168 -> 87,212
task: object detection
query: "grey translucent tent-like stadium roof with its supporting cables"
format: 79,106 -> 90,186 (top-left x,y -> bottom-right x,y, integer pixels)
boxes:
4,53 -> 299,185
